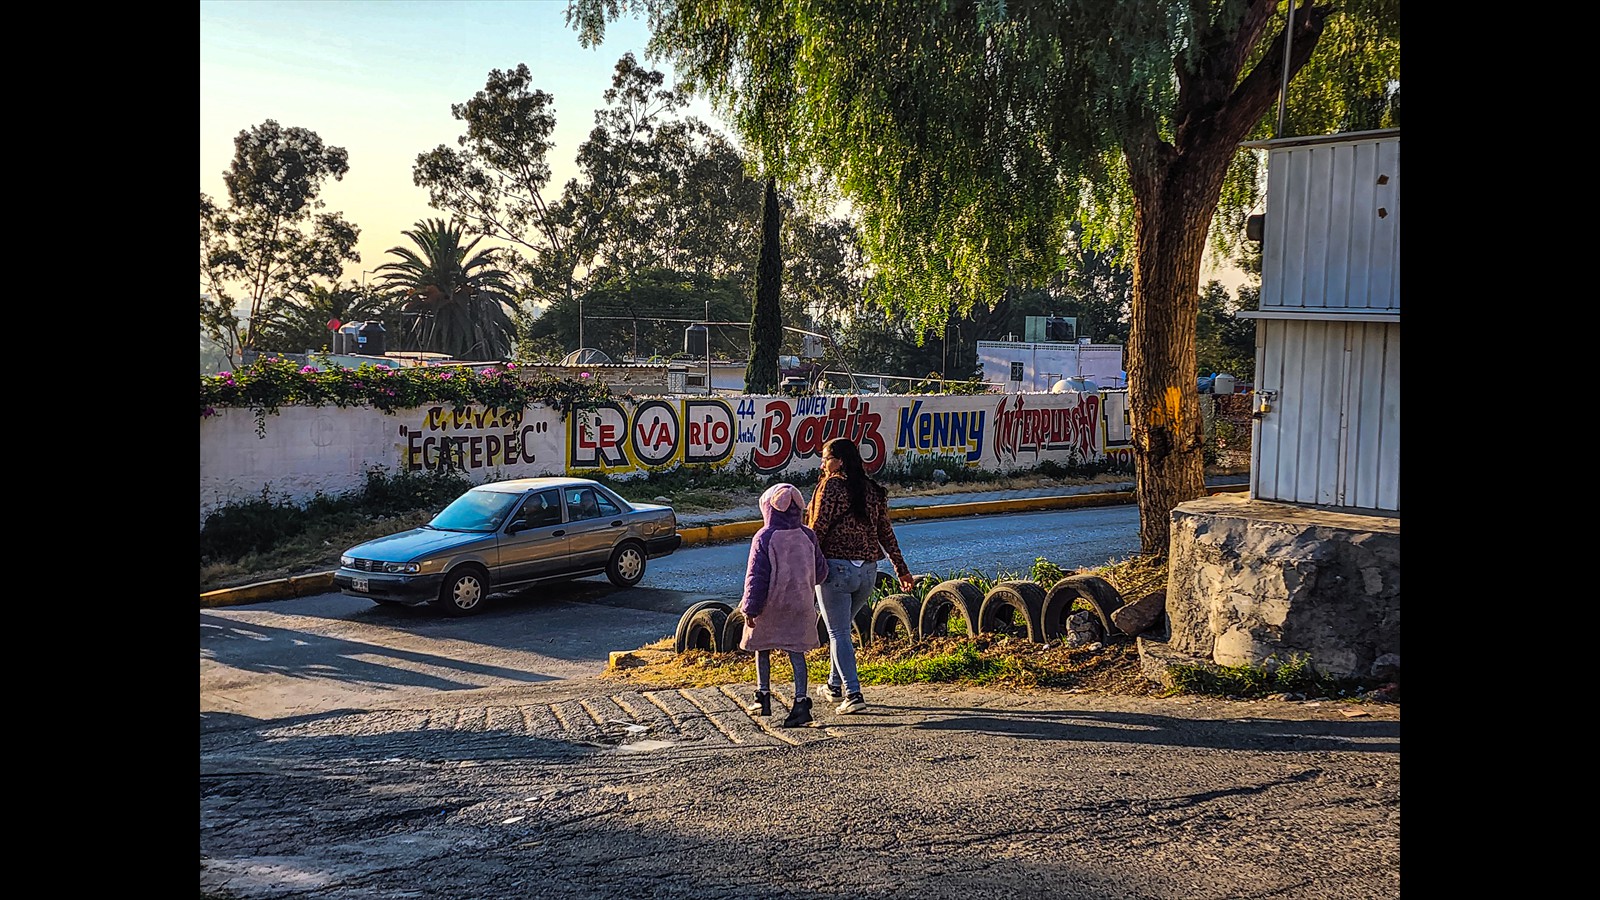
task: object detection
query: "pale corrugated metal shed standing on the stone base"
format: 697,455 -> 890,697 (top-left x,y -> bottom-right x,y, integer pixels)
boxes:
1240,128 -> 1400,514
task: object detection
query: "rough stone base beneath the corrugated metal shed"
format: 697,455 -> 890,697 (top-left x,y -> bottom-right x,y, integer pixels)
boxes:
1166,495 -> 1400,677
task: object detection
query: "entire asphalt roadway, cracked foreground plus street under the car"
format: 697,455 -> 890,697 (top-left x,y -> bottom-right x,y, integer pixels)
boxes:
198,508 -> 1400,900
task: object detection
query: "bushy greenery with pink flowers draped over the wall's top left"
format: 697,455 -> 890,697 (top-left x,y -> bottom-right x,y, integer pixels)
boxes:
200,356 -> 611,434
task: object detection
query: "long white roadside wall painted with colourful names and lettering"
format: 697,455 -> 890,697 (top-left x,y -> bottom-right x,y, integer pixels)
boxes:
200,391 -> 1131,524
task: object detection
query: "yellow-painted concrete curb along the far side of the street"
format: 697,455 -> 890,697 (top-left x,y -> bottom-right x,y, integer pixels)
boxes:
200,484 -> 1250,609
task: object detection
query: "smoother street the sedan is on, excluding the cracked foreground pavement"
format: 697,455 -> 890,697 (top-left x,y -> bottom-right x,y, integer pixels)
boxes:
200,506 -> 1139,727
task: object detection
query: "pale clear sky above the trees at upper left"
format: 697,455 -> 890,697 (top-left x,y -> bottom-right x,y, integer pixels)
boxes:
200,0 -> 720,280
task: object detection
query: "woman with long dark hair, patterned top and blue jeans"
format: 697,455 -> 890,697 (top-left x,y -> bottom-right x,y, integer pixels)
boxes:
806,437 -> 915,713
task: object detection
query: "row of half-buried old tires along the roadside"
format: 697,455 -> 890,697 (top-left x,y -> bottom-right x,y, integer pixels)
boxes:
674,575 -> 1123,653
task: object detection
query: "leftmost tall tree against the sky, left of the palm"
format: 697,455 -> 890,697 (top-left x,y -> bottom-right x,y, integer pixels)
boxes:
200,119 -> 362,359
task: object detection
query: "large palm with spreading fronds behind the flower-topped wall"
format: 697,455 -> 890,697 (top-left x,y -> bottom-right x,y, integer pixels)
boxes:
378,219 -> 517,360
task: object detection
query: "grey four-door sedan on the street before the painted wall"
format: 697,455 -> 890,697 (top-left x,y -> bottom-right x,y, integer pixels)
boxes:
333,477 -> 683,615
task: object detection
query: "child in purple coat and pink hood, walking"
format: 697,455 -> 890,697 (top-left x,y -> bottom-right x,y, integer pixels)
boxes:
739,484 -> 827,729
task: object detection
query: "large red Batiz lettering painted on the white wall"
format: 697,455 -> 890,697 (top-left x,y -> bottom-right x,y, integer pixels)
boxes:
750,397 -> 886,472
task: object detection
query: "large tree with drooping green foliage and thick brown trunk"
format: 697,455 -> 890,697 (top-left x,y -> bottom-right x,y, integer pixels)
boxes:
568,0 -> 1400,556
